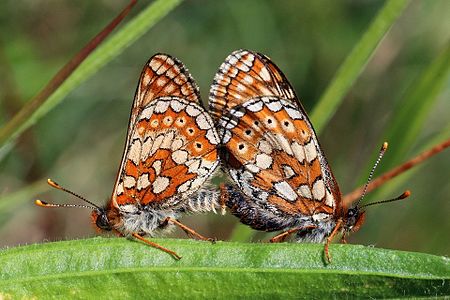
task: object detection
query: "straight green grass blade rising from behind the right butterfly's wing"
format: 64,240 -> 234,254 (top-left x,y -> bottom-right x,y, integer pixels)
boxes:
310,0 -> 410,134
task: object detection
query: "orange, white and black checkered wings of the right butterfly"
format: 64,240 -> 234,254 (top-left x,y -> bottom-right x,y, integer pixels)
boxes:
210,50 -> 341,217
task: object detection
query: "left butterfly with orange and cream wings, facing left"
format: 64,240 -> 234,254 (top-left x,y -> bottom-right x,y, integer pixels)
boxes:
36,54 -> 219,258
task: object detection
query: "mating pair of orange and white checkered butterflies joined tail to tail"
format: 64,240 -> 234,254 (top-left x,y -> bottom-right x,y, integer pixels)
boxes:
37,50 -> 406,259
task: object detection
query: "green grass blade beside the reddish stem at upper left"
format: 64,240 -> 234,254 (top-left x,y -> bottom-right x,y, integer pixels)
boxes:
0,0 -> 181,148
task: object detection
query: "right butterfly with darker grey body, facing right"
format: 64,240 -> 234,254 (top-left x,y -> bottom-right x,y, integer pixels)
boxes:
209,50 -> 409,261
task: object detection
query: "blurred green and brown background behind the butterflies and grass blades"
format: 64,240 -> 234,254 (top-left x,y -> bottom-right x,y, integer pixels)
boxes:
0,0 -> 450,255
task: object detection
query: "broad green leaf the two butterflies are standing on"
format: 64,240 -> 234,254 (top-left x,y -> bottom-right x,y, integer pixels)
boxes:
0,238 -> 450,299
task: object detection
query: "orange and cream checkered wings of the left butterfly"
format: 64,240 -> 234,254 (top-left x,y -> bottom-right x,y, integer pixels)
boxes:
112,54 -> 219,207
